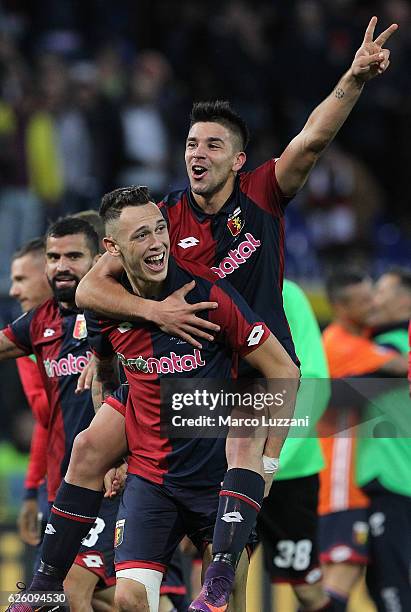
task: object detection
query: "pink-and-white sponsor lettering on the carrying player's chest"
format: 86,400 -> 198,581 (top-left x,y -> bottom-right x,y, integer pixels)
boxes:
117,349 -> 205,374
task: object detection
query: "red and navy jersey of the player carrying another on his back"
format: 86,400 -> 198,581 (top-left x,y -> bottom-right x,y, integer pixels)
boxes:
86,257 -> 270,486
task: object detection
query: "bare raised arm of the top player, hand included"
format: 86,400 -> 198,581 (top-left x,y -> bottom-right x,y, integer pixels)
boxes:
276,17 -> 398,196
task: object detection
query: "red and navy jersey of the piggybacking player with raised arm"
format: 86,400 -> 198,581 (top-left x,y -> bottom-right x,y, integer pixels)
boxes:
160,159 -> 298,363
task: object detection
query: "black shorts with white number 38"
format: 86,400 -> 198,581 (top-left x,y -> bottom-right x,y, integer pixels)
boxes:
257,474 -> 321,584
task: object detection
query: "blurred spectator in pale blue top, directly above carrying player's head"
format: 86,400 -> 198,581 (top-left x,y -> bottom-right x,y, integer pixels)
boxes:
118,51 -> 172,199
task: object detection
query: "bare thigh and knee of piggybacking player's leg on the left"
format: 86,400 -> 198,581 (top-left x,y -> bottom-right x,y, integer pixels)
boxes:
67,404 -> 127,476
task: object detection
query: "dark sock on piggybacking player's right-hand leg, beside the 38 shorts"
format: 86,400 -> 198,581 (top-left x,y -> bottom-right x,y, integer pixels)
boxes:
213,468 -> 264,567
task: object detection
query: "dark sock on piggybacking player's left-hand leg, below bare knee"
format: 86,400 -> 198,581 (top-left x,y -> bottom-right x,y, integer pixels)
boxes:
30,480 -> 103,590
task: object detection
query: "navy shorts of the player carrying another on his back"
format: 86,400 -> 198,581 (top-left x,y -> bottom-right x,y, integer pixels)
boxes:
114,474 -> 221,573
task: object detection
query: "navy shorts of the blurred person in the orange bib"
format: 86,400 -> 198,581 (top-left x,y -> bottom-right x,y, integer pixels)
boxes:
319,508 -> 369,565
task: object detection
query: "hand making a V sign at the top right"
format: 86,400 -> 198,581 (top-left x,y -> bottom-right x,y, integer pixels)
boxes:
351,17 -> 398,84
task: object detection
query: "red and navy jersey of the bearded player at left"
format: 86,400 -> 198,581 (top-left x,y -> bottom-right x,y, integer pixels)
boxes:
3,298 -> 94,500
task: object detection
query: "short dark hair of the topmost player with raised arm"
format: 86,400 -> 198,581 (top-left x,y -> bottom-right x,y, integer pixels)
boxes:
190,100 -> 250,151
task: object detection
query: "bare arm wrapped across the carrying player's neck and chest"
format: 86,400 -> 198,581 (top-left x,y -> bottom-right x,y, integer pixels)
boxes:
76,254 -> 219,348
